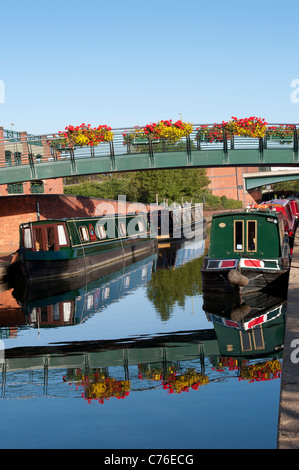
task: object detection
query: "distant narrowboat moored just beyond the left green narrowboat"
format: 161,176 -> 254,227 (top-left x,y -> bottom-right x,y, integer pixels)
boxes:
149,204 -> 206,240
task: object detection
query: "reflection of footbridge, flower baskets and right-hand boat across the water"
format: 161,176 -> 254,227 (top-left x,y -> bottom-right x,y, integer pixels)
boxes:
2,294 -> 285,404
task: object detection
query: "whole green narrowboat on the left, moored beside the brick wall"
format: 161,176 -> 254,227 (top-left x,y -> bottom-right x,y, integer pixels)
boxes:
8,213 -> 157,283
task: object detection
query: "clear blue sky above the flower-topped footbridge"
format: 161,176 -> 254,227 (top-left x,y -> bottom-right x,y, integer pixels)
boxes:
0,0 -> 299,134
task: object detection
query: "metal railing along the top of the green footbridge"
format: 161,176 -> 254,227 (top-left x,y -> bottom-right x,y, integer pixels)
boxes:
0,124 -> 299,169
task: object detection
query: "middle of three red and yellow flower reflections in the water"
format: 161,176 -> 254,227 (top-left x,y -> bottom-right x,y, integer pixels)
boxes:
163,369 -> 209,393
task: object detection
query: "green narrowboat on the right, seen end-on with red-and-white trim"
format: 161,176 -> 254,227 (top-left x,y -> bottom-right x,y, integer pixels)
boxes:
201,209 -> 290,293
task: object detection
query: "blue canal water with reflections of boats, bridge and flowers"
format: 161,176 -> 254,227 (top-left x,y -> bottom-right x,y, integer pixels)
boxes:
0,237 -> 286,449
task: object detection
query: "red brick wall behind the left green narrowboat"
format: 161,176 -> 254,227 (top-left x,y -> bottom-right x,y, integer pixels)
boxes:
0,194 -> 152,253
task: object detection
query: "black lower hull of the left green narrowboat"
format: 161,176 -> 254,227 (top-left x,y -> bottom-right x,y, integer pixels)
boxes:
8,238 -> 157,283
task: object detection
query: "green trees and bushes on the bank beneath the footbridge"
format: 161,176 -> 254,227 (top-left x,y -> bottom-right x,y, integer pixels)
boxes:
64,168 -> 242,210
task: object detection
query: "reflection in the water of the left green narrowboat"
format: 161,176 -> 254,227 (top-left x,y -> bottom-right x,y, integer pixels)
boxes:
13,255 -> 156,327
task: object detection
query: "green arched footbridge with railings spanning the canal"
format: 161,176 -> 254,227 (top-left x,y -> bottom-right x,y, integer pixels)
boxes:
0,124 -> 299,184
